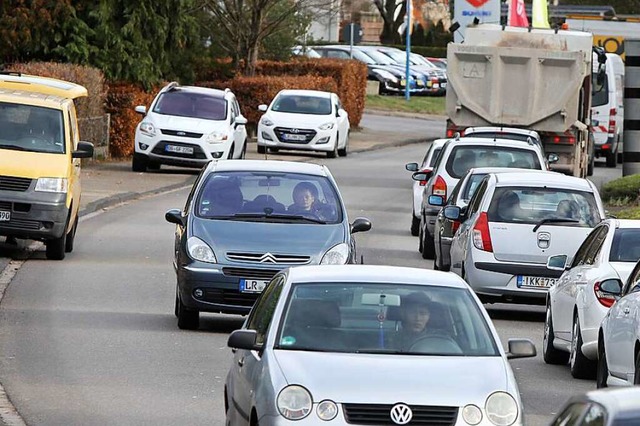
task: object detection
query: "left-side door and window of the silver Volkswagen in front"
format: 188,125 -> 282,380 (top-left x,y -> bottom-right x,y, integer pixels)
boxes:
231,275 -> 284,423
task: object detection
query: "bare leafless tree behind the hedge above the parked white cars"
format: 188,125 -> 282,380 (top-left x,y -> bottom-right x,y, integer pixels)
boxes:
203,0 -> 335,76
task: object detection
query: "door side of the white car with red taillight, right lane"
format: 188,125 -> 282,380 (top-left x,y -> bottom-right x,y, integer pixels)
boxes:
551,225 -> 609,341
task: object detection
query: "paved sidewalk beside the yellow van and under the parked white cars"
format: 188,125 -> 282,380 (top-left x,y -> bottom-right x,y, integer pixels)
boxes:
80,115 -> 425,216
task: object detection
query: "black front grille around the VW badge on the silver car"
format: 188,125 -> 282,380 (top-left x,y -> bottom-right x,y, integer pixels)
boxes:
342,404 -> 458,426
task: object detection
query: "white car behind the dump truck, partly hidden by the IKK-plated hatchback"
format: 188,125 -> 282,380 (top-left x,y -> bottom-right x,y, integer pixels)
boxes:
414,137 -> 546,259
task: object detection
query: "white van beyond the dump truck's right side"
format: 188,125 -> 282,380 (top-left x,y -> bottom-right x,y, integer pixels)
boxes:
591,53 -> 624,167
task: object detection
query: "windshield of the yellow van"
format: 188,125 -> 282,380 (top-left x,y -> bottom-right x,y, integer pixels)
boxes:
0,102 -> 65,154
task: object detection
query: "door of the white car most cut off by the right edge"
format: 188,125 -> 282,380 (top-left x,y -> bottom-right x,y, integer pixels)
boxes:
604,262 -> 640,383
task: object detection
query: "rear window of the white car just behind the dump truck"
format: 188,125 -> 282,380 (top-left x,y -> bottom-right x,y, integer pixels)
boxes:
446,145 -> 542,179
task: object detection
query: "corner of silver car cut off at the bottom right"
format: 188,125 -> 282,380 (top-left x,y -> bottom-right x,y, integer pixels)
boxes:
551,387 -> 640,426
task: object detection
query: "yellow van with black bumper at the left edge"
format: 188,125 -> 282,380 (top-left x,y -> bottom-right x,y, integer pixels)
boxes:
0,72 -> 93,260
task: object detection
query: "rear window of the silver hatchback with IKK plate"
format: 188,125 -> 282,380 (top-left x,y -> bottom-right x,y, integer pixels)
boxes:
488,187 -> 601,228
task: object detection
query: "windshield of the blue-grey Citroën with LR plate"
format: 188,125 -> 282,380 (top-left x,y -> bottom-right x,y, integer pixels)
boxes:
196,172 -> 343,223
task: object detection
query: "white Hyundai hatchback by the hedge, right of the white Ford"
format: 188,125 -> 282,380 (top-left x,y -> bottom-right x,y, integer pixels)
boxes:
258,90 -> 351,158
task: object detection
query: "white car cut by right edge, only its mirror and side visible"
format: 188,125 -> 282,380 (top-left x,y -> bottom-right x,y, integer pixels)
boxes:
596,255 -> 640,388
